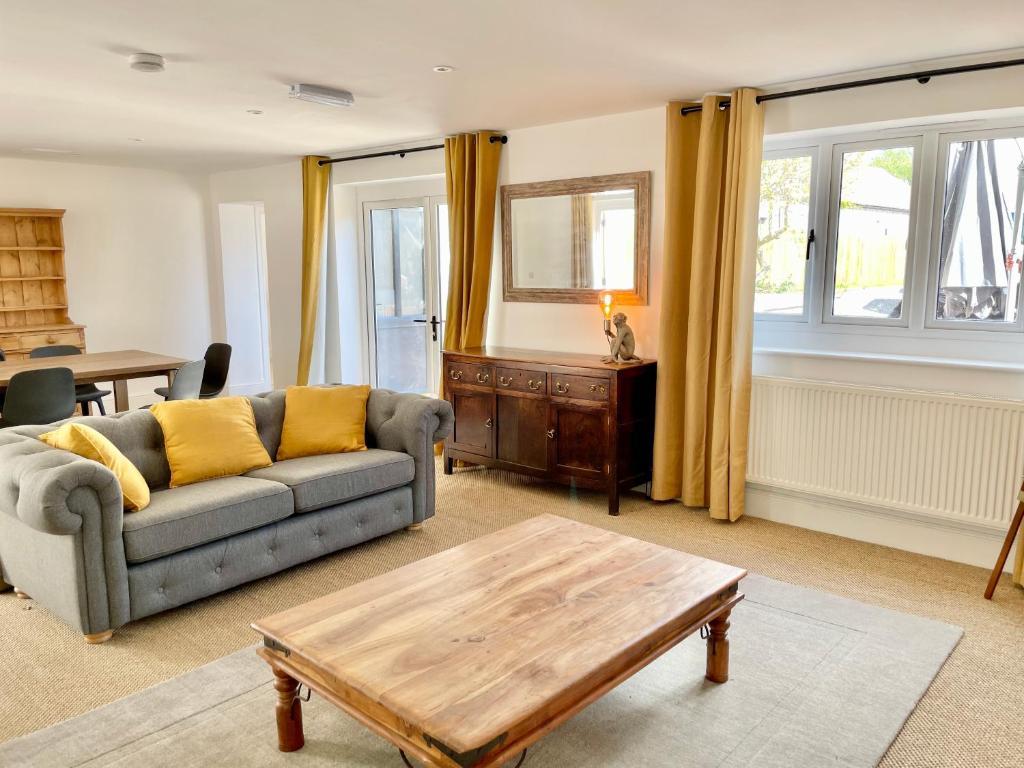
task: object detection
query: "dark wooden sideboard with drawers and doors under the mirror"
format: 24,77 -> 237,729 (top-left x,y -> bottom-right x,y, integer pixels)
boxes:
443,347 -> 657,515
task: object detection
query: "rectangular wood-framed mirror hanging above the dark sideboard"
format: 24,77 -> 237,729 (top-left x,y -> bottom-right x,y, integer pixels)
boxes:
502,171 -> 651,304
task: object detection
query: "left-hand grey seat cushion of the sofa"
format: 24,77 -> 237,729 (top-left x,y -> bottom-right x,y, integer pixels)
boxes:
123,477 -> 295,563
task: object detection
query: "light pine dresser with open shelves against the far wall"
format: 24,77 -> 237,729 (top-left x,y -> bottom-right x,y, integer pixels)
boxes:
0,208 -> 85,360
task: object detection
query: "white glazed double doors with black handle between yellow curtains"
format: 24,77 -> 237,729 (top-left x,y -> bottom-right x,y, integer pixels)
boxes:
365,198 -> 447,394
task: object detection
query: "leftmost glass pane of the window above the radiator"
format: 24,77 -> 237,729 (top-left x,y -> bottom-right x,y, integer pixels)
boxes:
754,155 -> 812,315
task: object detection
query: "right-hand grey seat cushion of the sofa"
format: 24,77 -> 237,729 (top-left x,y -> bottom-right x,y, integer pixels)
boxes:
246,449 -> 416,512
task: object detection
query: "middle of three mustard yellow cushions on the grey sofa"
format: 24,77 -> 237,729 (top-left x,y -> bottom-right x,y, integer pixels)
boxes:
150,397 -> 273,488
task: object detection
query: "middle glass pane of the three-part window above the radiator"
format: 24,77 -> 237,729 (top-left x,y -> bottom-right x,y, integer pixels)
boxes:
833,146 -> 913,318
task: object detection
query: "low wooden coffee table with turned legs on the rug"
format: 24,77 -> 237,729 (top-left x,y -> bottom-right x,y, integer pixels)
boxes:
247,515 -> 746,768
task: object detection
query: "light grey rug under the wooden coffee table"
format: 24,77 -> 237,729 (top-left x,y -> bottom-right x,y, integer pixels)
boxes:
0,575 -> 963,768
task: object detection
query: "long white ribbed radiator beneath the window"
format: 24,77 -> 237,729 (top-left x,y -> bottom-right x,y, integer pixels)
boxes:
746,377 -> 1024,531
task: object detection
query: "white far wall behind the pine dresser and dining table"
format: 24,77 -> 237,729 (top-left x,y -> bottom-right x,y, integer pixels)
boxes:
0,158 -> 211,406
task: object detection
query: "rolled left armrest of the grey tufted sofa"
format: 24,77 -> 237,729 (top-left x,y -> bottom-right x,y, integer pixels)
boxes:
0,434 -> 130,634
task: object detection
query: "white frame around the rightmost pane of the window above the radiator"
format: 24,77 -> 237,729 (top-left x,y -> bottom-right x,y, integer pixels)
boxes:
925,127 -> 1024,334
